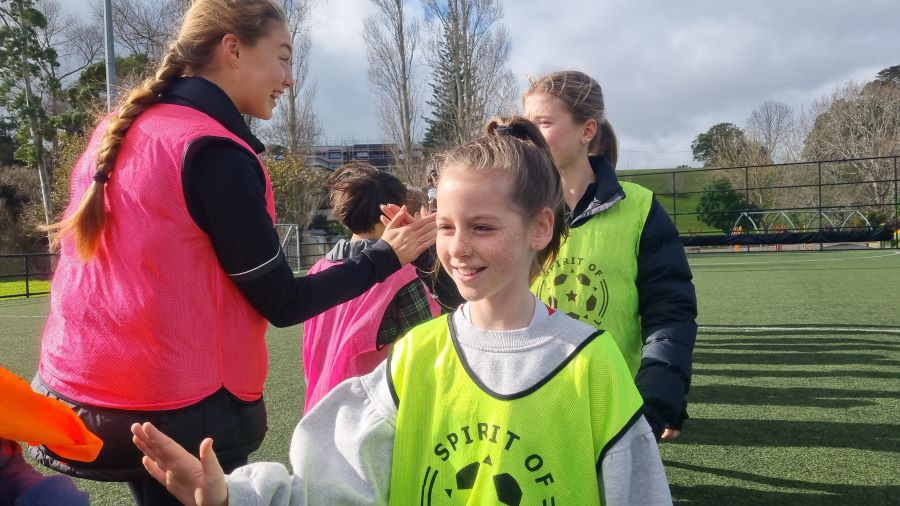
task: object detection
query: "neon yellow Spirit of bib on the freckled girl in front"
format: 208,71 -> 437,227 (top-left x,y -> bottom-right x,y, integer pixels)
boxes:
388,315 -> 643,506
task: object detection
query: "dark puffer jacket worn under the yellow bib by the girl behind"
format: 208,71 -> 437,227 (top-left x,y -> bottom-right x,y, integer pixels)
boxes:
569,156 -> 697,434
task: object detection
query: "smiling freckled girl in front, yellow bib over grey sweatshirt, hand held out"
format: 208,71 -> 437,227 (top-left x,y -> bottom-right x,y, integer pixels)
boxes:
132,118 -> 671,505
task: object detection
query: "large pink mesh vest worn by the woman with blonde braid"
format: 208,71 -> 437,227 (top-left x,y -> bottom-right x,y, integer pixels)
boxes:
39,104 -> 275,410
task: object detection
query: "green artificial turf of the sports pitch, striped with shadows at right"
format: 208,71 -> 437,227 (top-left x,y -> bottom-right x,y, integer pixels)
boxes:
0,250 -> 900,505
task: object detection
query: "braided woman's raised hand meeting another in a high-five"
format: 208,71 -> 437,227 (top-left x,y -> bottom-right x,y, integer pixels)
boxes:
381,205 -> 437,265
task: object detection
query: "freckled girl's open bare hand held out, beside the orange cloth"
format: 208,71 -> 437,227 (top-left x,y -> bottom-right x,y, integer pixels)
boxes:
131,422 -> 228,506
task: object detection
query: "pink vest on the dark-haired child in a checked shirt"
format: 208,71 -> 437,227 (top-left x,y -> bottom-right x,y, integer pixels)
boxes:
303,258 -> 441,414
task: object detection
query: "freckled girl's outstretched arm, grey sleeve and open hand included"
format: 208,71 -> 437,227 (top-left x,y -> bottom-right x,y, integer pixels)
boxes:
132,362 -> 396,506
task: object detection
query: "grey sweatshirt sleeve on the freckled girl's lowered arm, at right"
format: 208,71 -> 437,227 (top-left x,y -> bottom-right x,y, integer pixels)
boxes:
597,416 -> 672,506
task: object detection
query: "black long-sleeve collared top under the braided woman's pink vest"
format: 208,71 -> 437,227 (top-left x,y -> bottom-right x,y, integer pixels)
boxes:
162,77 -> 400,327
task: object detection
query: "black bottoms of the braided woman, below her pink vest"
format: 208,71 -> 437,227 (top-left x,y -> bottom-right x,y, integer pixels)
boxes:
31,376 -> 268,481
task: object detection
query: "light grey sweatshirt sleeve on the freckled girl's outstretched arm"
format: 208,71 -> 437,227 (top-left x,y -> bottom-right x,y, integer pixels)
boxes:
227,362 -> 397,506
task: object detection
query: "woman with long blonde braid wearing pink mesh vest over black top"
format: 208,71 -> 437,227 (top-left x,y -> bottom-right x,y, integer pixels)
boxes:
33,0 -> 435,504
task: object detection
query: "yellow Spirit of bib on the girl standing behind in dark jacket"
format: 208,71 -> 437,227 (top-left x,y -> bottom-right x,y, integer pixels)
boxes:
531,182 -> 653,376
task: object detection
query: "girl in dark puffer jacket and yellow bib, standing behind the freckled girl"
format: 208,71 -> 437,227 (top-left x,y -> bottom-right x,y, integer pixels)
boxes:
524,71 -> 697,439
